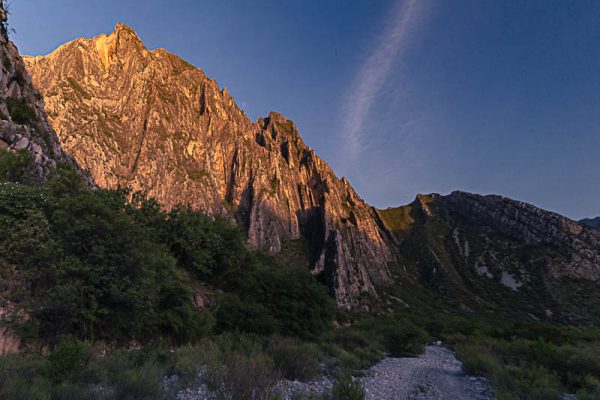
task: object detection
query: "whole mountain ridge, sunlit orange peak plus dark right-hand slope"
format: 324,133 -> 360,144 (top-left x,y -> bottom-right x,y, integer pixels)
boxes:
25,24 -> 600,325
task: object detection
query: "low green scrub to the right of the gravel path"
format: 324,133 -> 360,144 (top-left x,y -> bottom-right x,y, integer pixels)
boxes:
437,318 -> 600,399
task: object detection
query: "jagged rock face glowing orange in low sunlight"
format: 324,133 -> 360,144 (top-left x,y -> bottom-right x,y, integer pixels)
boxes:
25,24 -> 392,308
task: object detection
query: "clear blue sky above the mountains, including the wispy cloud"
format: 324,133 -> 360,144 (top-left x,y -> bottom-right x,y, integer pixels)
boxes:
10,0 -> 600,218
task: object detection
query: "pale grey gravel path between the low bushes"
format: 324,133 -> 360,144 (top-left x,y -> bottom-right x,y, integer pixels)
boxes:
360,346 -> 494,400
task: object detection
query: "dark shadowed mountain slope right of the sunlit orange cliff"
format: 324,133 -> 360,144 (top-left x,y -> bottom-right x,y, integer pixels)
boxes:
379,192 -> 600,325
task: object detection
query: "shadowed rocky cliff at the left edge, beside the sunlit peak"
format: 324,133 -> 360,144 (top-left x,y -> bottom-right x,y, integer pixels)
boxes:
0,0 -> 72,179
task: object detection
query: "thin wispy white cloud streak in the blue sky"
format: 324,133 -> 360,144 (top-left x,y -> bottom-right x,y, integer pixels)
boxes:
342,0 -> 427,160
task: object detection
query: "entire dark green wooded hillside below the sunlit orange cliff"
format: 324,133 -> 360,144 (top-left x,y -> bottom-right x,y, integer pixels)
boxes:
0,153 -> 334,344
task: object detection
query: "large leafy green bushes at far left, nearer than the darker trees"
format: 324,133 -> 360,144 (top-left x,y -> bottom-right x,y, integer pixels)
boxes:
0,173 -> 212,344
